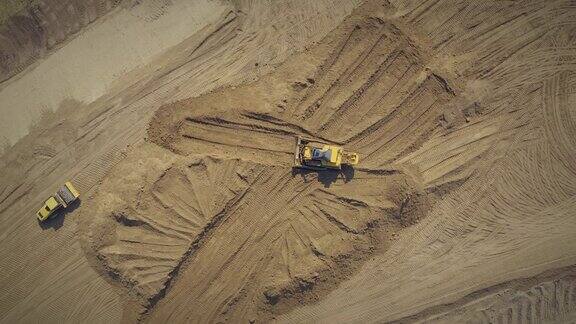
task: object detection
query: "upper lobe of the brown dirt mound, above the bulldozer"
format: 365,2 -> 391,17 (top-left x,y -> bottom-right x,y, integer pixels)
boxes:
148,16 -> 454,176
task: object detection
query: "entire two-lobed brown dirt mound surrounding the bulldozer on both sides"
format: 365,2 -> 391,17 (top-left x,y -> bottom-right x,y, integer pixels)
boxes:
80,3 -> 464,321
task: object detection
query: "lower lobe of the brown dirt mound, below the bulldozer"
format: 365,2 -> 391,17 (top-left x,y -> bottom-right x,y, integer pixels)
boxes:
87,140 -> 429,320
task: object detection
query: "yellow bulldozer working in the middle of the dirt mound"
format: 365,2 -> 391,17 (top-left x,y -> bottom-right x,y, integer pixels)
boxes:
294,137 -> 359,170
